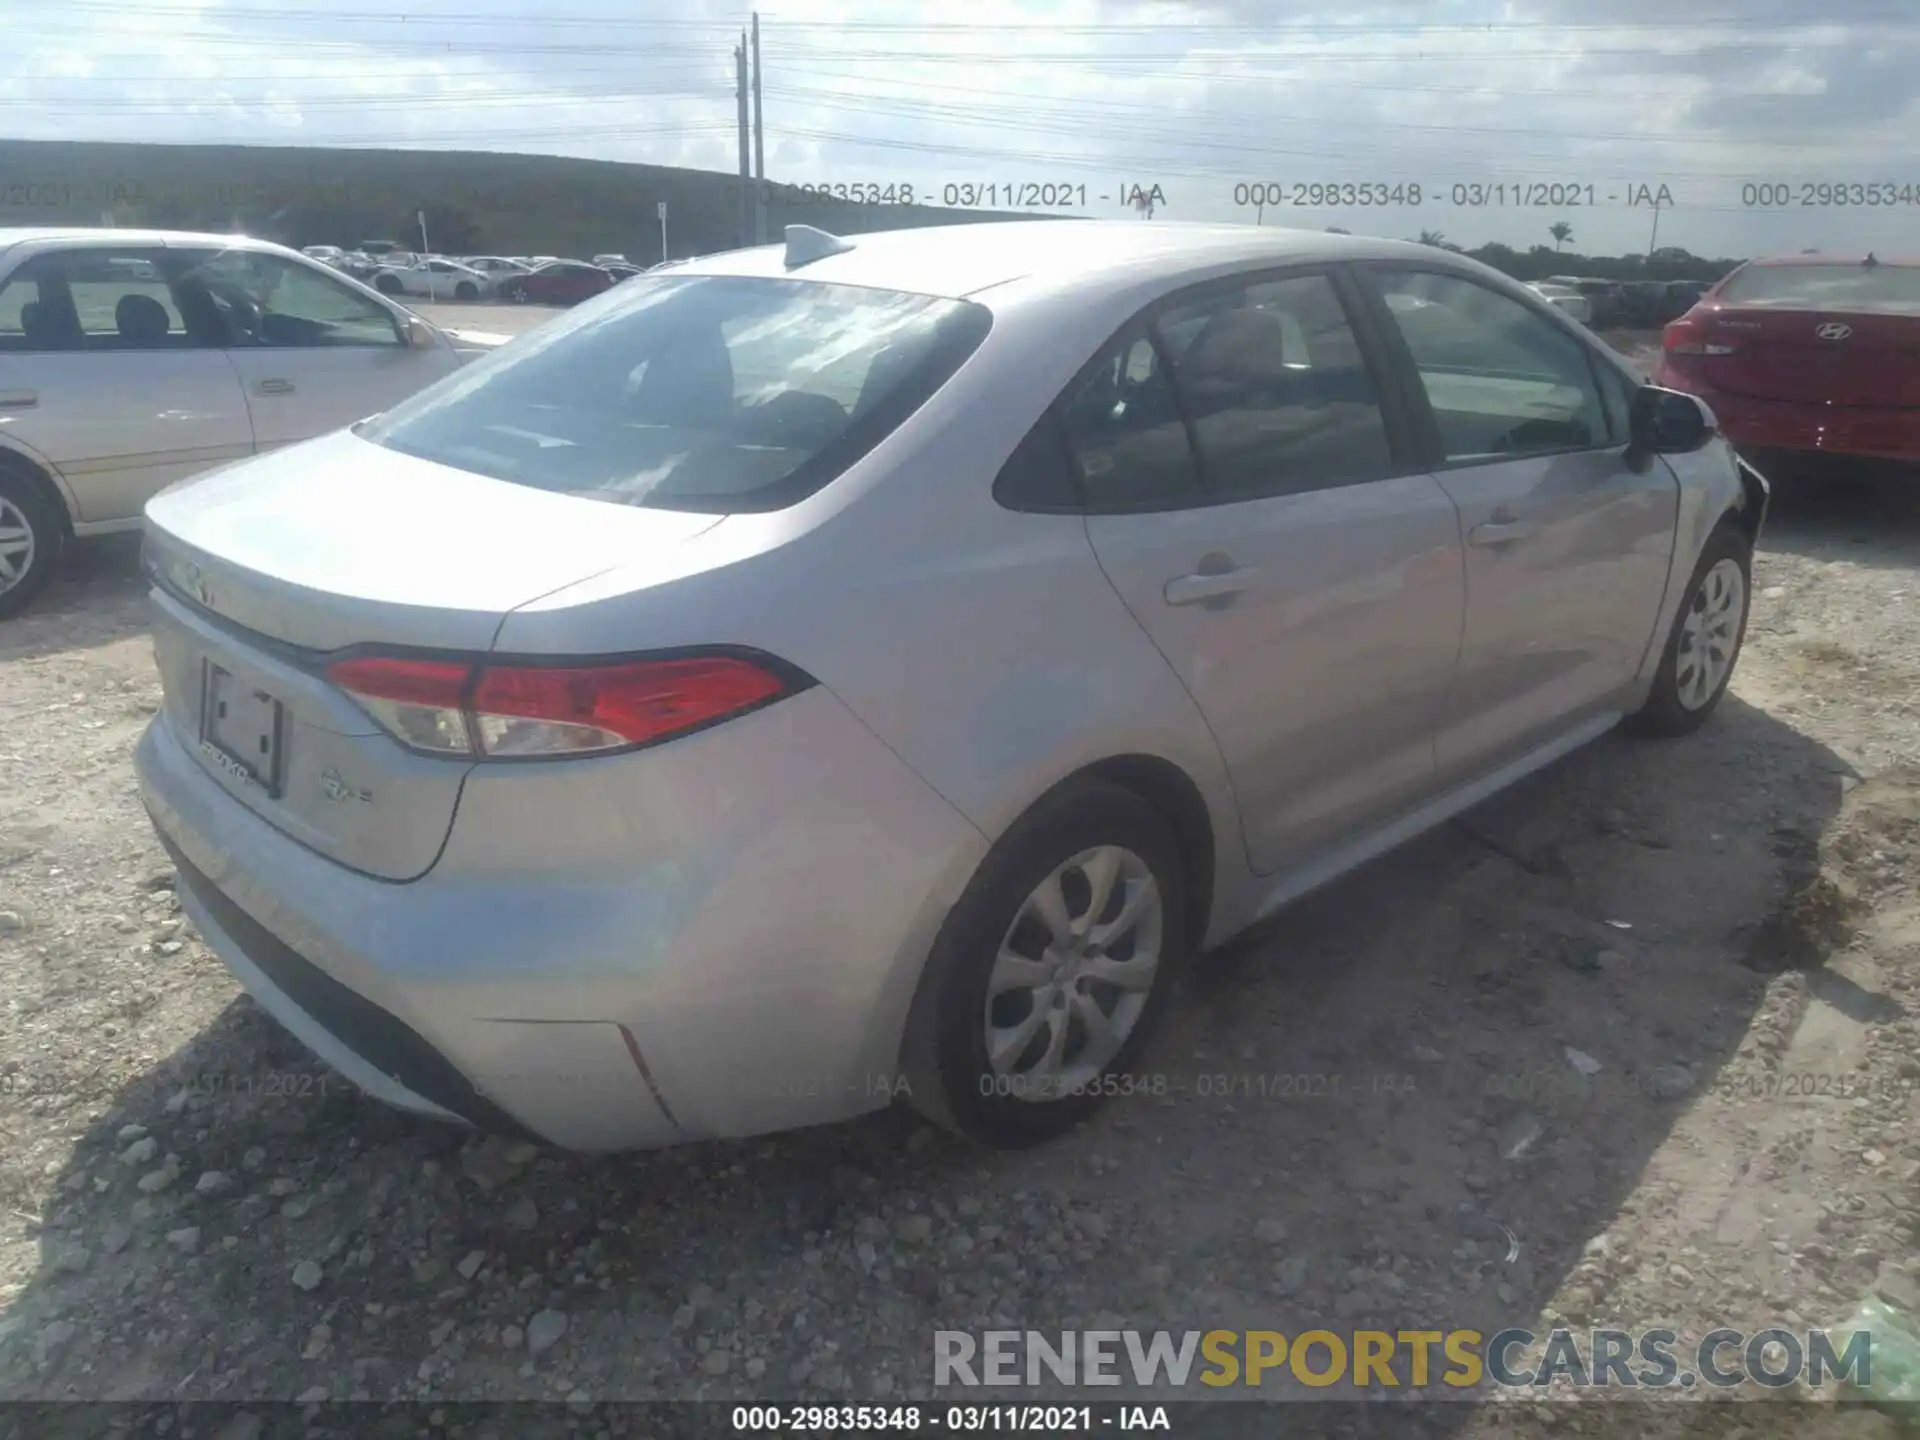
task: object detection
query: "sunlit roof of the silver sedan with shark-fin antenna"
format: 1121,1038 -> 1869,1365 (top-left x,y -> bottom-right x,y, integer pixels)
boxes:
674,219 -> 1459,300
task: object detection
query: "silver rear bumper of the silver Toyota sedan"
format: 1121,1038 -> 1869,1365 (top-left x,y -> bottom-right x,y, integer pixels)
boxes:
134,687 -> 985,1150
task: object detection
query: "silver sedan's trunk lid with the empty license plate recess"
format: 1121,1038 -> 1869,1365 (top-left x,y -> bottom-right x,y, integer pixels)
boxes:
146,432 -> 724,879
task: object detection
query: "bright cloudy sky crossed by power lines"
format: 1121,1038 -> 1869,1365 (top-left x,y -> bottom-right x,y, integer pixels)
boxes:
0,0 -> 1920,255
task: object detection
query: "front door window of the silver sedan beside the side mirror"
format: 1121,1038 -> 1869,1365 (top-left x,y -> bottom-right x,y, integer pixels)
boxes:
1373,271 -> 1609,463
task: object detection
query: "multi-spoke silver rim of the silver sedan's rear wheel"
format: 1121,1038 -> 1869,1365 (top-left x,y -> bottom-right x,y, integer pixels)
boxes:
985,845 -> 1165,1102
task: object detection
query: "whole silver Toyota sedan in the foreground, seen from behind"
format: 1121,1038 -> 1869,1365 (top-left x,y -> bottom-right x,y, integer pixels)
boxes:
134,221 -> 1764,1150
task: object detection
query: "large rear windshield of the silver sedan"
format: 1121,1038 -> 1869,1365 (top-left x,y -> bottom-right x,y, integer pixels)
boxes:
359,275 -> 989,515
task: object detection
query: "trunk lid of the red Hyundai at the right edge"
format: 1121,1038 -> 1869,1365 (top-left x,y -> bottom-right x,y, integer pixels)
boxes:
1693,307 -> 1920,409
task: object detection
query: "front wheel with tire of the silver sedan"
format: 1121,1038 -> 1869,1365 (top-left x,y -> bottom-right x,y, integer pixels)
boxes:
1626,518 -> 1753,737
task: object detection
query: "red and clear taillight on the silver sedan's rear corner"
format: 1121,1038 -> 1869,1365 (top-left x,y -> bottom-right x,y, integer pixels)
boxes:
326,655 -> 797,758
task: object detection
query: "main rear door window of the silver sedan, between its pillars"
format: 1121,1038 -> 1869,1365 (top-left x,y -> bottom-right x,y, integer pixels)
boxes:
1160,275 -> 1394,497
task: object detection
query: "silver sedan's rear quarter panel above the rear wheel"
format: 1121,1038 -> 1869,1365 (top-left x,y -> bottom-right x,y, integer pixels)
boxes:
497,289 -> 1244,948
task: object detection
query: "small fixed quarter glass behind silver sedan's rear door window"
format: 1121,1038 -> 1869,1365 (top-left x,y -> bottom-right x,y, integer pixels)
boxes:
1060,330 -> 1200,511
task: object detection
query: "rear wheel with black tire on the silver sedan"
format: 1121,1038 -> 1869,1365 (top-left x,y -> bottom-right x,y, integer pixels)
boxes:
906,781 -> 1190,1148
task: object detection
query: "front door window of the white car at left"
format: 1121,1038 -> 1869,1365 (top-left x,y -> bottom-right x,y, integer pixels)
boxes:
182,250 -> 405,349
